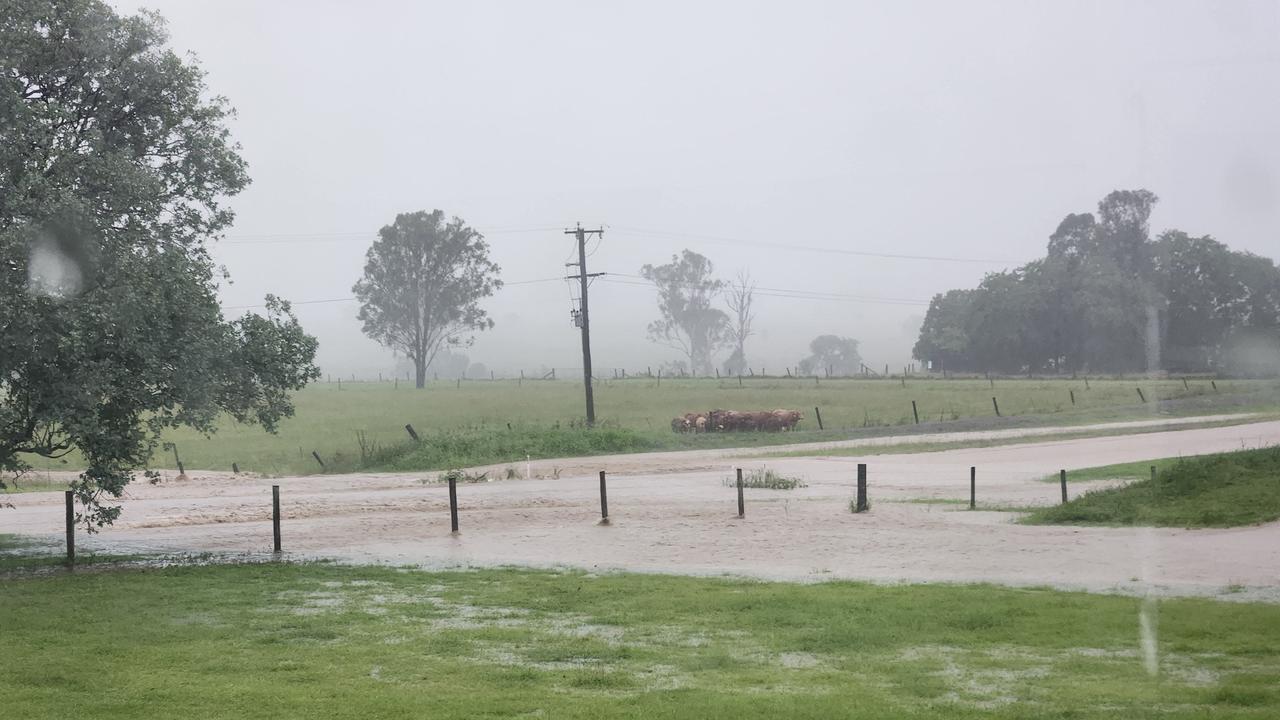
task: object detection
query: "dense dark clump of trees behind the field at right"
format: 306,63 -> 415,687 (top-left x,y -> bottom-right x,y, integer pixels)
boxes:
913,190 -> 1280,374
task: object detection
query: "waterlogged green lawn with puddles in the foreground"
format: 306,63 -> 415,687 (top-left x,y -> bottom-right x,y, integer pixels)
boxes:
0,564 -> 1280,719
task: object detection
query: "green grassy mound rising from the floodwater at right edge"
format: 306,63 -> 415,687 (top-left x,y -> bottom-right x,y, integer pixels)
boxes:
1023,447 -> 1280,528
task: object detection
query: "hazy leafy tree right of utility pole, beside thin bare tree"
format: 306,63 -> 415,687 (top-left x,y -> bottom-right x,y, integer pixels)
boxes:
640,250 -> 730,375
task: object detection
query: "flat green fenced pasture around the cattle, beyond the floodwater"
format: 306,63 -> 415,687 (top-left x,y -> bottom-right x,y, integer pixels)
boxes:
12,378 -> 1280,474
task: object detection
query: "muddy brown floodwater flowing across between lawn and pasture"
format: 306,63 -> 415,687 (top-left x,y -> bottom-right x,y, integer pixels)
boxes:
10,418 -> 1280,602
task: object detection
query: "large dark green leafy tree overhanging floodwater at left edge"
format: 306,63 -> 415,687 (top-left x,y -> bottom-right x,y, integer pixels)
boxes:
0,0 -> 319,530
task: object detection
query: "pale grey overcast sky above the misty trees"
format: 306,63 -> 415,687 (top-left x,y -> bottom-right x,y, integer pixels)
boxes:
116,0 -> 1280,375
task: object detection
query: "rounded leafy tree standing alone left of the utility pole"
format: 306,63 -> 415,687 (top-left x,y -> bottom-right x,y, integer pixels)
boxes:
352,210 -> 502,387
